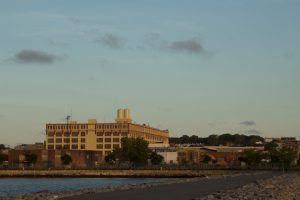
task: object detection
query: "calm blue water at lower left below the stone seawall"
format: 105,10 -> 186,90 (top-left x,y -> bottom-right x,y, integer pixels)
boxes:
0,178 -> 166,196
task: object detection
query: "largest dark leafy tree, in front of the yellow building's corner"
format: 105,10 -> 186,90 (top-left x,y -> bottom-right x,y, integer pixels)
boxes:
105,138 -> 149,165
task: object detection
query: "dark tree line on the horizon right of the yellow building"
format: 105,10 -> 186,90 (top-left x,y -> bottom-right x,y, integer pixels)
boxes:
169,133 -> 264,146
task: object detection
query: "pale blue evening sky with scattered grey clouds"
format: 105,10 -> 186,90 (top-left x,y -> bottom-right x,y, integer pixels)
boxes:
0,0 -> 300,145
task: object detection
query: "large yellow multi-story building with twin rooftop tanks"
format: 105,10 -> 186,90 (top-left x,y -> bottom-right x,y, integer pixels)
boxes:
46,109 -> 169,155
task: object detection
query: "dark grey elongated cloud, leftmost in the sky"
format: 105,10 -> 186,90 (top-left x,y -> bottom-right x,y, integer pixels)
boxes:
13,49 -> 62,64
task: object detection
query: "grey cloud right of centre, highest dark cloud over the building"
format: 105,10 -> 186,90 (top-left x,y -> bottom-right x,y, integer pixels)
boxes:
169,39 -> 205,53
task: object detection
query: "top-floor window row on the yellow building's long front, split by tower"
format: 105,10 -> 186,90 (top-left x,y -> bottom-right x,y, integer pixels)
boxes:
47,124 -> 128,130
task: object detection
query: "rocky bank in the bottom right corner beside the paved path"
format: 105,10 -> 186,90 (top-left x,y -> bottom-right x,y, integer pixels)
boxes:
198,173 -> 300,200
